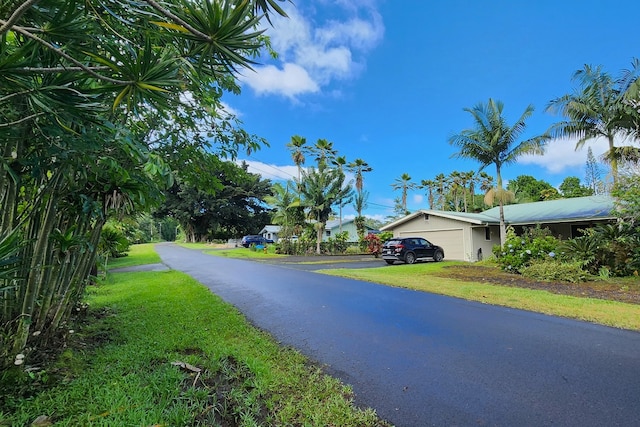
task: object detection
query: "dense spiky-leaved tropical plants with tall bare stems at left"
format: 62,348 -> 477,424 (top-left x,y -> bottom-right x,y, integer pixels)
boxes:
0,0 -> 282,369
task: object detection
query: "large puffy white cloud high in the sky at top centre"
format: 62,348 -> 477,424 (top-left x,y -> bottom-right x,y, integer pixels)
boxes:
241,1 -> 384,99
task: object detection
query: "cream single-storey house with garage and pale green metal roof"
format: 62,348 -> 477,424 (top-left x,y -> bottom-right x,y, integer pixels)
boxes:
380,196 -> 615,261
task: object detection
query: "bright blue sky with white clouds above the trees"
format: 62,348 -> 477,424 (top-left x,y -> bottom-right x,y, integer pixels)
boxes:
224,0 -> 640,219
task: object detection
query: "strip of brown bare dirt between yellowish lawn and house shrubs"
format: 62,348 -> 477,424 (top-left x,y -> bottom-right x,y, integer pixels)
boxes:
438,265 -> 640,304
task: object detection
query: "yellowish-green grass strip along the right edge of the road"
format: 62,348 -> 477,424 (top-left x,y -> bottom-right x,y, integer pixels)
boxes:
318,262 -> 640,330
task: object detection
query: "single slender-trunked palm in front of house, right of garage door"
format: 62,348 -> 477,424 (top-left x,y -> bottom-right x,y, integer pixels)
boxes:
449,99 -> 550,246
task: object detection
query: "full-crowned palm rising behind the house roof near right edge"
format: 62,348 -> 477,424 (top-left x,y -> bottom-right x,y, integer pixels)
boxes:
547,65 -> 637,184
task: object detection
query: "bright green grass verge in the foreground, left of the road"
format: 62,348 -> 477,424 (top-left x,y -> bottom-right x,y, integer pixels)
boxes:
5,256 -> 388,426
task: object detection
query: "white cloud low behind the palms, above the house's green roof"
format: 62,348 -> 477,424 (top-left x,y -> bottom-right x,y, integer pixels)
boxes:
518,138 -> 609,174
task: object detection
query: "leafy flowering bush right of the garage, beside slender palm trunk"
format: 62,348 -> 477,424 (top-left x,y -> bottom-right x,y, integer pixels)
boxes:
493,227 -> 559,273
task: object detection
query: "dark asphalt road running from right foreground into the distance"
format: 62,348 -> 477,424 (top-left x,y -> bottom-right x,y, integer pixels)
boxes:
156,244 -> 640,427
